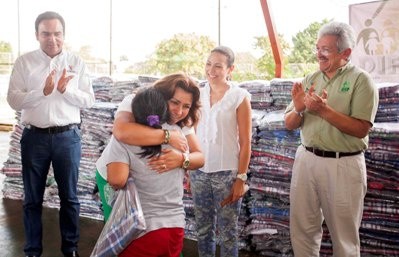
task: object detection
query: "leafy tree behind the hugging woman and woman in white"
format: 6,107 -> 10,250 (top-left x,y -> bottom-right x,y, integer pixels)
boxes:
141,33 -> 216,78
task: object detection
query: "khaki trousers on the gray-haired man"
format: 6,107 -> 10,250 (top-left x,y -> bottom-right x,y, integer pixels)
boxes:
290,145 -> 367,257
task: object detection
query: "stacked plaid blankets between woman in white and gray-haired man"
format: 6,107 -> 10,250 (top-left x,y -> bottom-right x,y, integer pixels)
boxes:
245,79 -> 300,256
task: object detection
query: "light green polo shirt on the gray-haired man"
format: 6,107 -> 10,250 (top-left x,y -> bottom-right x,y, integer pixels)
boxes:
285,63 -> 379,152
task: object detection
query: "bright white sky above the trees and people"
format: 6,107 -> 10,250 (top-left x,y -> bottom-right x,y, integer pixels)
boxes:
0,0 -> 370,62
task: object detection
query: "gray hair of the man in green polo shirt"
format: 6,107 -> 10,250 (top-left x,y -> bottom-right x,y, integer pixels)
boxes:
318,21 -> 356,52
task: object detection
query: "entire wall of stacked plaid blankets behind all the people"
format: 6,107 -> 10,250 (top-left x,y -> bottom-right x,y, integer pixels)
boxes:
1,76 -> 399,254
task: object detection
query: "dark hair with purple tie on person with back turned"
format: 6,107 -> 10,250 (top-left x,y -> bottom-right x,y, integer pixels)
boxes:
132,87 -> 169,158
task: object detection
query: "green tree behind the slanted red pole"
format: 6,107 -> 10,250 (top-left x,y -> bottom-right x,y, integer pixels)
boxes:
255,35 -> 290,80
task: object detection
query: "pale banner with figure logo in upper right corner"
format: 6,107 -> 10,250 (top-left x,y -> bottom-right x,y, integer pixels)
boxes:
349,0 -> 399,83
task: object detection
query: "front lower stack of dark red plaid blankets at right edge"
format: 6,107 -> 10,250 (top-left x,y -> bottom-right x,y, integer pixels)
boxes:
360,121 -> 399,256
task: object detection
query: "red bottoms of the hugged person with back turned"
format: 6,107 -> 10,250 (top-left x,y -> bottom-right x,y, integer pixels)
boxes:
118,228 -> 184,257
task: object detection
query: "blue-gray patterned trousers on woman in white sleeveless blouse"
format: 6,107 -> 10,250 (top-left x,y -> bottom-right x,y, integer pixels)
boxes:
190,170 -> 241,257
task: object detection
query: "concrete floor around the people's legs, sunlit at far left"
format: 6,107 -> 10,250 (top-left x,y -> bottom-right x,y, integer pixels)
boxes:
0,131 -> 258,257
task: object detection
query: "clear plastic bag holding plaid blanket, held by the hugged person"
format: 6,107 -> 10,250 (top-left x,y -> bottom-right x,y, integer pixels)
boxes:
90,177 -> 146,257
